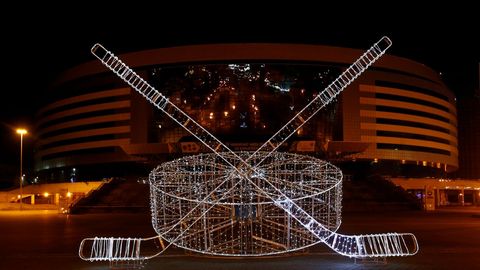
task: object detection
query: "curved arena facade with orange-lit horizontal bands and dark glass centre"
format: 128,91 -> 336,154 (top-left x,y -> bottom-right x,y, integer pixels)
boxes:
35,44 -> 458,179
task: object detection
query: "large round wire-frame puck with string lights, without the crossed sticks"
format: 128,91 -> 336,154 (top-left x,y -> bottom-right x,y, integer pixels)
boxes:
150,152 -> 342,256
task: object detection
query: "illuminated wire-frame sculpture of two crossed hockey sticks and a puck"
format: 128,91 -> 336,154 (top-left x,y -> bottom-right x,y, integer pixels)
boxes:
79,37 -> 418,262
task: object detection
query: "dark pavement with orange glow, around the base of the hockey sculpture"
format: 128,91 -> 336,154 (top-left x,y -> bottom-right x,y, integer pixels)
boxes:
0,210 -> 480,270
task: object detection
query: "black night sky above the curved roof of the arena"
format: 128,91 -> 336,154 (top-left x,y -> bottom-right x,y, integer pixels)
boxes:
0,7 -> 480,188
